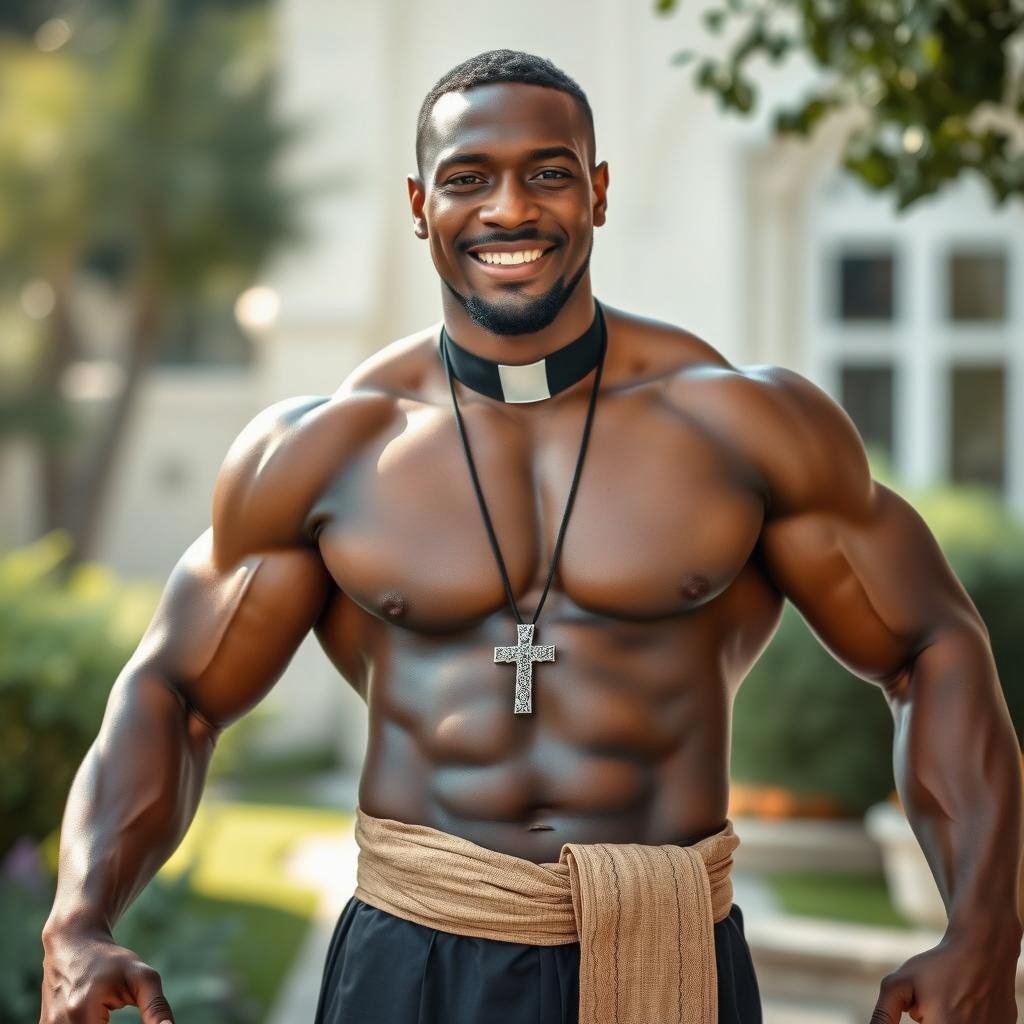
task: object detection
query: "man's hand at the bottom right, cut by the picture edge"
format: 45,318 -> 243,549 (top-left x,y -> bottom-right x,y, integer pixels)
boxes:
870,933 -> 1021,1024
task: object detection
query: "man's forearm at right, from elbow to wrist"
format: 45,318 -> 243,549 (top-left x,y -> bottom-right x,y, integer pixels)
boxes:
892,629 -> 1022,938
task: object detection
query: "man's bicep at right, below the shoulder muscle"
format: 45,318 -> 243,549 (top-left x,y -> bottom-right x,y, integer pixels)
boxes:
759,478 -> 984,686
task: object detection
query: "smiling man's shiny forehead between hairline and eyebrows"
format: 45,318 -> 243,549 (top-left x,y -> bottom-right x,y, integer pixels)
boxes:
429,83 -> 587,171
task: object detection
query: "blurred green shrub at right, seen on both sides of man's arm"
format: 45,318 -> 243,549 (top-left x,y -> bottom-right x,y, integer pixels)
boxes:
732,472 -> 1024,815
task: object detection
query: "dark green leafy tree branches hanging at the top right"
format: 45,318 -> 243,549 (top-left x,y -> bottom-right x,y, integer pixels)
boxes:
655,0 -> 1024,210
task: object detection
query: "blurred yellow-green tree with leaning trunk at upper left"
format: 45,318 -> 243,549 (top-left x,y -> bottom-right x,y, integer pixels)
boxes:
0,0 -> 344,565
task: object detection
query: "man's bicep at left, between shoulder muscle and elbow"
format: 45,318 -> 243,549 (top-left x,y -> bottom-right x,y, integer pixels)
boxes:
125,528 -> 331,730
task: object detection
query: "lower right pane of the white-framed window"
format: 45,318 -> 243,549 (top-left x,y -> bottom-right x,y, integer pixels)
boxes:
949,367 -> 1006,490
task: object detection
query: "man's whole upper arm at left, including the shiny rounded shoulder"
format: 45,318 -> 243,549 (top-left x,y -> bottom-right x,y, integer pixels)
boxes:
121,396 -> 333,730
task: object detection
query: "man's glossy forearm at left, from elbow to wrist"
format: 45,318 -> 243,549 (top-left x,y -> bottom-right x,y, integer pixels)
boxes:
47,668 -> 214,931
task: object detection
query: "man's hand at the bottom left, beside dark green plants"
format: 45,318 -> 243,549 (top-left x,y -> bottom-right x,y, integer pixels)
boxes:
39,928 -> 174,1024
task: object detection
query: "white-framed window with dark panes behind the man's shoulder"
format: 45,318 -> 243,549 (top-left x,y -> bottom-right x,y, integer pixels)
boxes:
795,172 -> 1024,514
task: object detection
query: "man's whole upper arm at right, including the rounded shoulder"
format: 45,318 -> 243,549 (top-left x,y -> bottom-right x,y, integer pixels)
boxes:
742,366 -> 985,689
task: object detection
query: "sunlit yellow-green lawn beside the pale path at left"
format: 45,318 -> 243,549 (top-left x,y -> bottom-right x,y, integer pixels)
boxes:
160,801 -> 351,1011
